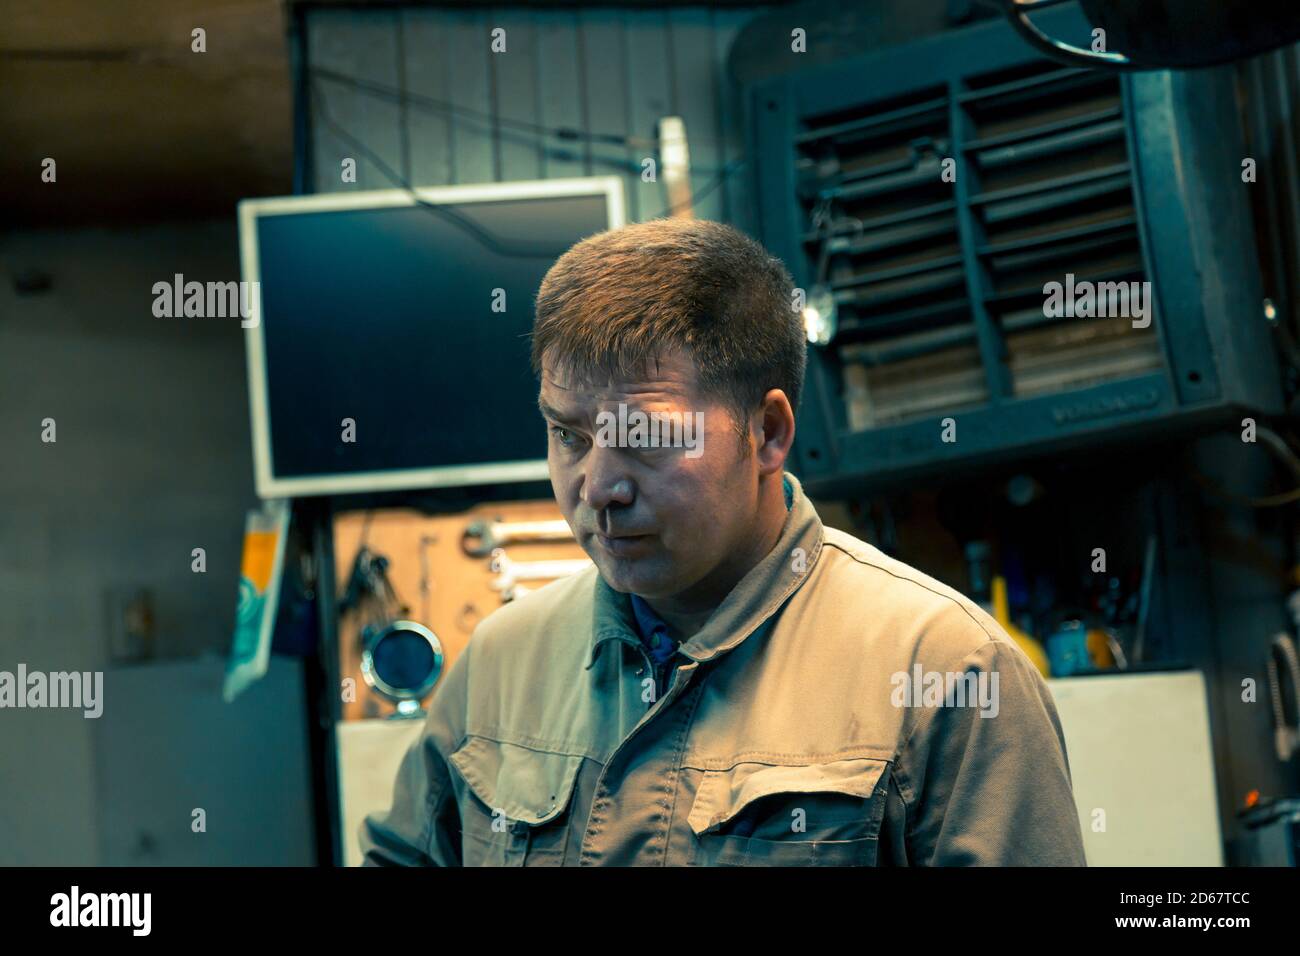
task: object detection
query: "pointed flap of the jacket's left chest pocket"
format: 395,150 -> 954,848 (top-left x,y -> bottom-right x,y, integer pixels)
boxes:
450,736 -> 582,826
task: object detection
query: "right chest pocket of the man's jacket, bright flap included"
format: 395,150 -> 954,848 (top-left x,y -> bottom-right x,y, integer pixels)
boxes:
686,757 -> 889,866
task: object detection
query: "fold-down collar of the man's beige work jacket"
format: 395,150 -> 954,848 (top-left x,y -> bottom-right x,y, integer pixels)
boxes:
586,472 -> 824,669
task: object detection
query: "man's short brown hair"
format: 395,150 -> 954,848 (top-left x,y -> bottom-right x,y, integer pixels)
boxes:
532,219 -> 807,434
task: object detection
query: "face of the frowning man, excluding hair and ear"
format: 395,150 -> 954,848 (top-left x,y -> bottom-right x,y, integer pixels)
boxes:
538,351 -> 759,605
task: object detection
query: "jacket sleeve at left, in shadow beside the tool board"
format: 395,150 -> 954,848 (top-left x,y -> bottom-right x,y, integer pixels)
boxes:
358,641 -> 472,866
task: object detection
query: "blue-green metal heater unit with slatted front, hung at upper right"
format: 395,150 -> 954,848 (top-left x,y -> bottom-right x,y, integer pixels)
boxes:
750,3 -> 1282,492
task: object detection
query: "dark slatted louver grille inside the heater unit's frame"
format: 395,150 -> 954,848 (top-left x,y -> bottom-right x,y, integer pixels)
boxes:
794,62 -> 1161,432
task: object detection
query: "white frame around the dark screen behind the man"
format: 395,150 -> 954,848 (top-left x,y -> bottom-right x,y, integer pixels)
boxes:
238,176 -> 627,498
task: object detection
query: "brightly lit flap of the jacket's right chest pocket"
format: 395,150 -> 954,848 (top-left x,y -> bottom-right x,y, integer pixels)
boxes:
686,757 -> 889,836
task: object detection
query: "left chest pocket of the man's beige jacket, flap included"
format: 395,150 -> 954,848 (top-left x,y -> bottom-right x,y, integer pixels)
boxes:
450,736 -> 582,866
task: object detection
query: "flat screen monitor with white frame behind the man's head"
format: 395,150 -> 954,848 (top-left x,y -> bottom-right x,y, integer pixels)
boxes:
239,177 -> 624,498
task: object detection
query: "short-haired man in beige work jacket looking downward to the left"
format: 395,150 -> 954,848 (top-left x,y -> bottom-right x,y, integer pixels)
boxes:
360,219 -> 1084,866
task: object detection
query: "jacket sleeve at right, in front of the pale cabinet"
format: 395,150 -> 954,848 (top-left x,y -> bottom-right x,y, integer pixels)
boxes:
894,639 -> 1087,866
